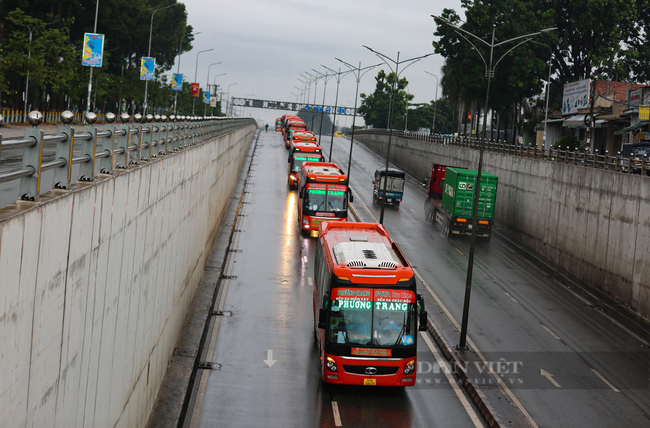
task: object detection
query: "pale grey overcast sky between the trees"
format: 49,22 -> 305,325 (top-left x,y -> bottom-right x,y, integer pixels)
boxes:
175,0 -> 464,126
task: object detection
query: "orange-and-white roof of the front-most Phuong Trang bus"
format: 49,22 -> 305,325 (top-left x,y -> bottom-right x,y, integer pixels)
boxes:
320,222 -> 413,287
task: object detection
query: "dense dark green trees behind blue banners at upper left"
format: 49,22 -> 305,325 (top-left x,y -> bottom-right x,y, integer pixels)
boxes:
0,0 -> 220,114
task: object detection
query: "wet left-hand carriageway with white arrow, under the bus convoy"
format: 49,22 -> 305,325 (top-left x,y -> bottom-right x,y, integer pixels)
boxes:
191,132 -> 483,428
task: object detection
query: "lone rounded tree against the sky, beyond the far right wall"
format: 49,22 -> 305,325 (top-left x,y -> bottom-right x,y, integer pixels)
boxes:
358,70 -> 413,129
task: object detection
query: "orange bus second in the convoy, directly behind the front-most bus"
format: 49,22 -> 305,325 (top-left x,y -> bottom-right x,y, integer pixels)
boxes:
298,162 -> 352,236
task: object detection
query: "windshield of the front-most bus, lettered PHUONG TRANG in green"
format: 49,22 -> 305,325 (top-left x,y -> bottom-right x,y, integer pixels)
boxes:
326,288 -> 416,347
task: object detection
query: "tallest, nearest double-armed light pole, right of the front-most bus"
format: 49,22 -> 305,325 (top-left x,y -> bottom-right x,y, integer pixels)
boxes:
431,15 -> 557,349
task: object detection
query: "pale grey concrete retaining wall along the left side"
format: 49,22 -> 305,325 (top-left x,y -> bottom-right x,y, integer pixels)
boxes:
0,125 -> 255,428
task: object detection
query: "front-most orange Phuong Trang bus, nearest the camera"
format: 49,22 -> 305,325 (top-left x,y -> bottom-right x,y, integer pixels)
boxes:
314,222 -> 427,386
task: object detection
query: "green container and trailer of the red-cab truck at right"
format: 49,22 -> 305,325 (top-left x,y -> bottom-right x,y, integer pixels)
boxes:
426,167 -> 499,239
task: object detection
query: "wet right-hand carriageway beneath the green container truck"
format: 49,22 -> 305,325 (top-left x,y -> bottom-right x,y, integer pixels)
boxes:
324,138 -> 650,427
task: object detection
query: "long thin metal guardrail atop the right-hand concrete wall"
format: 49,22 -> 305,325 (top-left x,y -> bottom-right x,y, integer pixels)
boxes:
354,129 -> 650,175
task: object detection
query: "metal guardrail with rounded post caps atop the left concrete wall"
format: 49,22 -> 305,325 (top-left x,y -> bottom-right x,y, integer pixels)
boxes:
0,111 -> 255,201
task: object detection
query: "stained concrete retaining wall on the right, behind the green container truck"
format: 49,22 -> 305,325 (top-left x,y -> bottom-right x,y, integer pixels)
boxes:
357,134 -> 650,321
